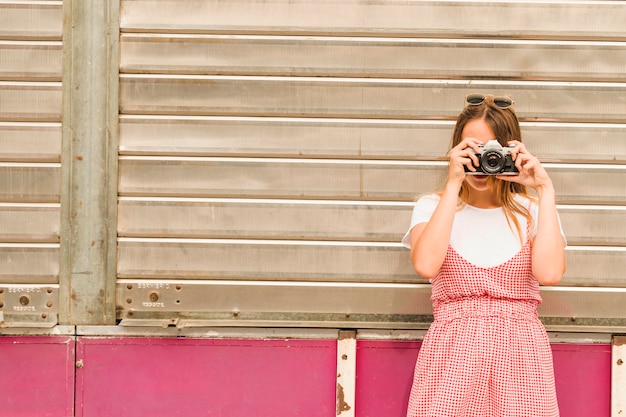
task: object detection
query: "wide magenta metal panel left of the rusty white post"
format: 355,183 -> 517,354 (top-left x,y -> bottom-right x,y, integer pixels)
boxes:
76,337 -> 337,417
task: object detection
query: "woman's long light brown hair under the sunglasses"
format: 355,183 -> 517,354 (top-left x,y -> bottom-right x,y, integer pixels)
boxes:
450,96 -> 532,244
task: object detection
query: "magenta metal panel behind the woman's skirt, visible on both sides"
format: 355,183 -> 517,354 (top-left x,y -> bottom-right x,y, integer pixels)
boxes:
356,340 -> 611,417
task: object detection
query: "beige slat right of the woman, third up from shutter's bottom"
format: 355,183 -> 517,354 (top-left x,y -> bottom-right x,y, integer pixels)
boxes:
558,206 -> 626,245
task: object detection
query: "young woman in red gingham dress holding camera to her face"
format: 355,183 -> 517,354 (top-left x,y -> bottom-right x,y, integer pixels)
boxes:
403,94 -> 565,417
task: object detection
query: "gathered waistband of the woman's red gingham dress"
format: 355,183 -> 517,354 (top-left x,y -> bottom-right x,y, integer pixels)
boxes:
433,297 -> 538,321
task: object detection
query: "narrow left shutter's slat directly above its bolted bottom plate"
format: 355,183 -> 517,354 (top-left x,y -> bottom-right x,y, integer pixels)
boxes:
0,243 -> 59,284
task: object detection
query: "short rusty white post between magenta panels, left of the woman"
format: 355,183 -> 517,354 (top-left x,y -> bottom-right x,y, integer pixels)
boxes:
337,330 -> 356,417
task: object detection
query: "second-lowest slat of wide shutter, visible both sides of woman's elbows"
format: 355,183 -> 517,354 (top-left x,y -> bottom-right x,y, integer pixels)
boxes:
118,238 -> 626,287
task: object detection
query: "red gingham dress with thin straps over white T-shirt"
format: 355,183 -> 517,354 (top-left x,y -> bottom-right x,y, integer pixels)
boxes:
407,228 -> 559,417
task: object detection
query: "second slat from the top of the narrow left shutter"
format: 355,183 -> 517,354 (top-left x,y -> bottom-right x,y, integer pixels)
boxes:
0,41 -> 63,81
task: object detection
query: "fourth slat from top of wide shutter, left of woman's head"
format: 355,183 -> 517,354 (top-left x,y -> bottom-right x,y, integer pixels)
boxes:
120,115 -> 454,159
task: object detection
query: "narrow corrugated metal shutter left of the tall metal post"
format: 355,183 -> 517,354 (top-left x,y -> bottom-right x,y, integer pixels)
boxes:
0,1 -> 63,327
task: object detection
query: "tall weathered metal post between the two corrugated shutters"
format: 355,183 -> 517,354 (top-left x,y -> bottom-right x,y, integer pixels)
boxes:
59,0 -> 119,325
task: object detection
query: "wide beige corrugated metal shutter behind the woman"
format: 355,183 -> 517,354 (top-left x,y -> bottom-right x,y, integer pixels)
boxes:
118,0 -> 626,331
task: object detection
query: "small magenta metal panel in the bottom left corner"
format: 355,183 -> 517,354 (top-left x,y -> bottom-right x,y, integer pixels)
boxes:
0,336 -> 74,417
